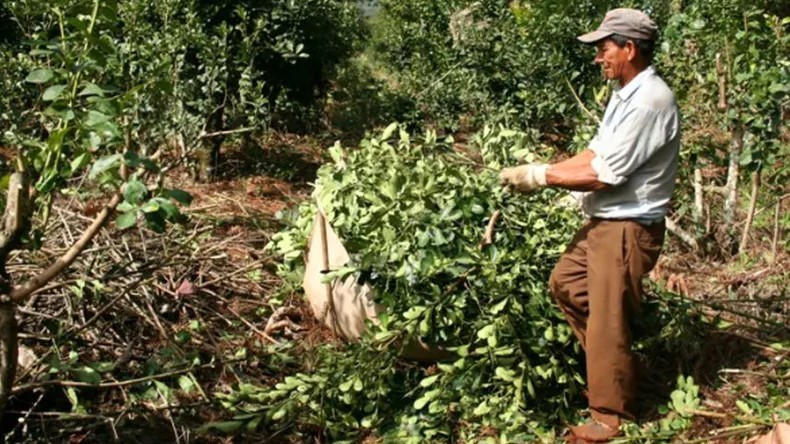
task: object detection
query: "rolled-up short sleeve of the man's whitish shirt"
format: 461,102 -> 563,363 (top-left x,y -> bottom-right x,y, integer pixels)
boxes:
590,106 -> 677,185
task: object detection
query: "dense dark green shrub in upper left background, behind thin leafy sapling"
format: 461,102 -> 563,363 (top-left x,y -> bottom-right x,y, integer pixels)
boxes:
0,0 -> 365,160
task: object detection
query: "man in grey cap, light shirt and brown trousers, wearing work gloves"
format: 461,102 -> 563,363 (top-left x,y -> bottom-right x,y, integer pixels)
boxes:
500,9 -> 680,443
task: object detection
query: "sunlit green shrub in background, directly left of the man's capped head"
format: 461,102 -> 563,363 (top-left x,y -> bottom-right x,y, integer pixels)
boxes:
373,0 -> 667,131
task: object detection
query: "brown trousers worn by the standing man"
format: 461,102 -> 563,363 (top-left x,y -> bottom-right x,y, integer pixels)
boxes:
549,219 -> 664,426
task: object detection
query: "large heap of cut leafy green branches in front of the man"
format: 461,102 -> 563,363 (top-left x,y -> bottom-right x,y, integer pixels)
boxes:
207,125 -> 596,441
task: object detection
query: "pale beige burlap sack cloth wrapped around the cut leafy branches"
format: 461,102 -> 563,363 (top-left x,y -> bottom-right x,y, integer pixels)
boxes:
302,211 -> 452,361
